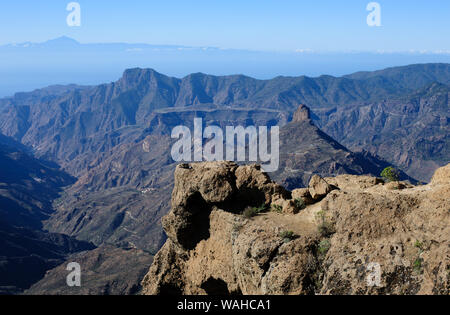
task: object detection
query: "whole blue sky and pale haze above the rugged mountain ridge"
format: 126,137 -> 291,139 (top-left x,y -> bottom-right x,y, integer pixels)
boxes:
0,0 -> 450,97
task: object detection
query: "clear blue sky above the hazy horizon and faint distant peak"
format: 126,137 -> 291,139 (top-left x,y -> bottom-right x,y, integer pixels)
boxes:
0,0 -> 450,51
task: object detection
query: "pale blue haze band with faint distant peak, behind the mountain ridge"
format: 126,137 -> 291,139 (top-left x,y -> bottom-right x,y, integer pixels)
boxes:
0,37 -> 450,97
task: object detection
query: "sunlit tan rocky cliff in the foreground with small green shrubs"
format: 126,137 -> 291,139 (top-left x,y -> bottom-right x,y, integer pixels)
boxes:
142,162 -> 450,294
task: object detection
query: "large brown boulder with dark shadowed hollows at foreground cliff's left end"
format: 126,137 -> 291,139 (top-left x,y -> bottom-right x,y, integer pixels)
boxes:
162,162 -> 290,250
